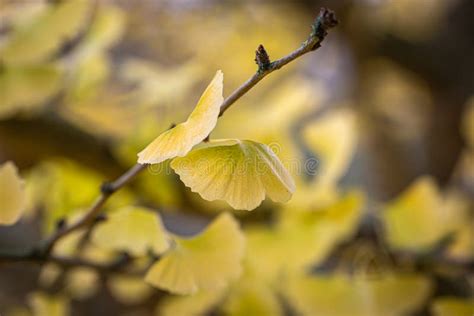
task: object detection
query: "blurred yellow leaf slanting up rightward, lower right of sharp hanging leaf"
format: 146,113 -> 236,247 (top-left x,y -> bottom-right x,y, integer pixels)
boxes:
244,191 -> 365,282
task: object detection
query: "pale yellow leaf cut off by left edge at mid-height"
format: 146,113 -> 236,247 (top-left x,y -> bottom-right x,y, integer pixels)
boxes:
0,161 -> 26,225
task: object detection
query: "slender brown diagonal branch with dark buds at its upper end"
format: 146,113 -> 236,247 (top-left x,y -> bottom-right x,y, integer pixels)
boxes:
0,8 -> 338,271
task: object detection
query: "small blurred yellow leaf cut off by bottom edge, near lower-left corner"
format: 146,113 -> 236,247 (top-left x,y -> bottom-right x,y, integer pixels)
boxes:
29,292 -> 70,316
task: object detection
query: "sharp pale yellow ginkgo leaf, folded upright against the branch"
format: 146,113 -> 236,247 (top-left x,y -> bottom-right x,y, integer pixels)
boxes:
138,70 -> 224,164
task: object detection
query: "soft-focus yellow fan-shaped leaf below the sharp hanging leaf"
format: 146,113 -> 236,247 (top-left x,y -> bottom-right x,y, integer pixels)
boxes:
145,213 -> 245,294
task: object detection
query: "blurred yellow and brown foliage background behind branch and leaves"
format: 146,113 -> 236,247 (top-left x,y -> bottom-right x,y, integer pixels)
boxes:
0,0 -> 474,316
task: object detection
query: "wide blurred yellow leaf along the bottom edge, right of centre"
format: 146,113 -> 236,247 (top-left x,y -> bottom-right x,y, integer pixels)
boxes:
282,274 -> 431,316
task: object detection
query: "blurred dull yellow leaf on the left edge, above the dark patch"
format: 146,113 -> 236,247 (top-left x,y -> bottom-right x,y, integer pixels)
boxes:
0,64 -> 62,119
